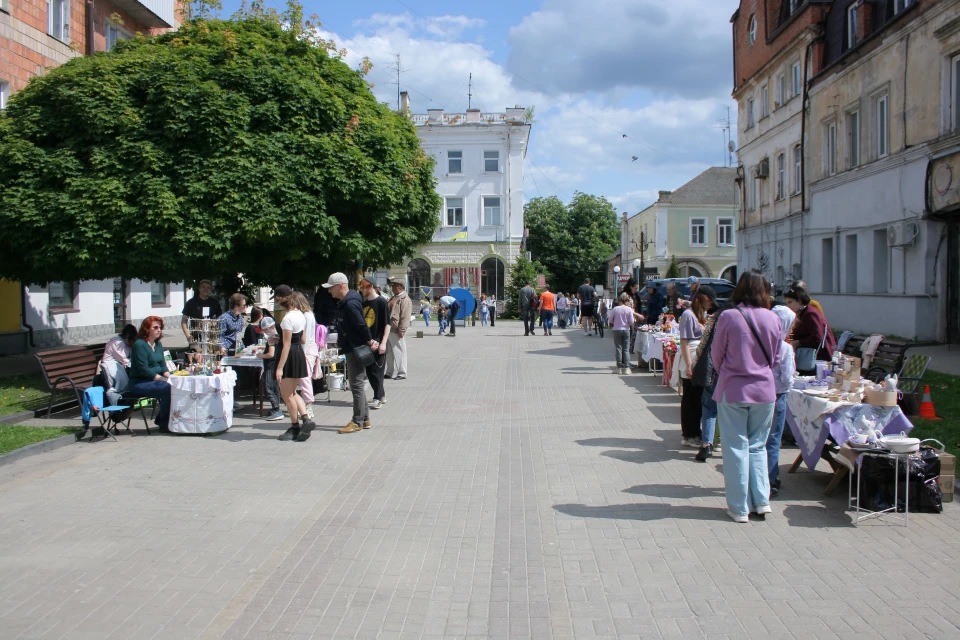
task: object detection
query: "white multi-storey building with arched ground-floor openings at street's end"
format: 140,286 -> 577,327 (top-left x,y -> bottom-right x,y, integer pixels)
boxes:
383,96 -> 531,300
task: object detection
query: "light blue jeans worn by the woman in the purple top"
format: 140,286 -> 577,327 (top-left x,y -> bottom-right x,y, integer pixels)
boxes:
717,395 -> 775,515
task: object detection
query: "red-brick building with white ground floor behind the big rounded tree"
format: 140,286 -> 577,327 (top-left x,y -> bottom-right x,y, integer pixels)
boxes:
0,0 -> 183,355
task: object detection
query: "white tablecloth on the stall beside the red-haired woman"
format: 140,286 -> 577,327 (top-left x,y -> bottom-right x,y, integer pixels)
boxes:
169,371 -> 237,433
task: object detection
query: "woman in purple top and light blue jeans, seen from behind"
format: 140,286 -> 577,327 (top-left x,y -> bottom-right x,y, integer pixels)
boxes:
710,271 -> 780,523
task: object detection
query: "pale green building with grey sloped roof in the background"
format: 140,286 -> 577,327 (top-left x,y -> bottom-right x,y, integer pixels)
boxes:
621,167 -> 740,281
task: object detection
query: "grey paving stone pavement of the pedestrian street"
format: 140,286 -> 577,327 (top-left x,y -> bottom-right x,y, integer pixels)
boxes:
0,322 -> 960,640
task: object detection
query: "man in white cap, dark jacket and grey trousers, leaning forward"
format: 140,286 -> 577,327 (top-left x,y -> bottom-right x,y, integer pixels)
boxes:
323,272 -> 380,433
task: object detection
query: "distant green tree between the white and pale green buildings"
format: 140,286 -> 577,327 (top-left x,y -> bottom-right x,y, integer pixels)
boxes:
523,191 -> 620,291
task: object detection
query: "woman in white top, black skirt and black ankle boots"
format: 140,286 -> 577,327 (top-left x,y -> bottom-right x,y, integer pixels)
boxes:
275,285 -> 316,442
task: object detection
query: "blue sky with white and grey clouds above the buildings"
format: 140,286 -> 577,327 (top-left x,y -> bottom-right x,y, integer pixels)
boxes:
223,0 -> 739,215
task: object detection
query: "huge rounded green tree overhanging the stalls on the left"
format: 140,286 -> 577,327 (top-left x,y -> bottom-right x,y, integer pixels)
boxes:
0,3 -> 440,284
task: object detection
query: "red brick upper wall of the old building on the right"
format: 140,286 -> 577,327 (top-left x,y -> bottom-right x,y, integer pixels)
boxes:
732,0 -> 827,93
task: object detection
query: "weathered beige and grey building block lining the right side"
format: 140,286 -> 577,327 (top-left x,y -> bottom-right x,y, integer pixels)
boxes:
732,0 -> 960,341
